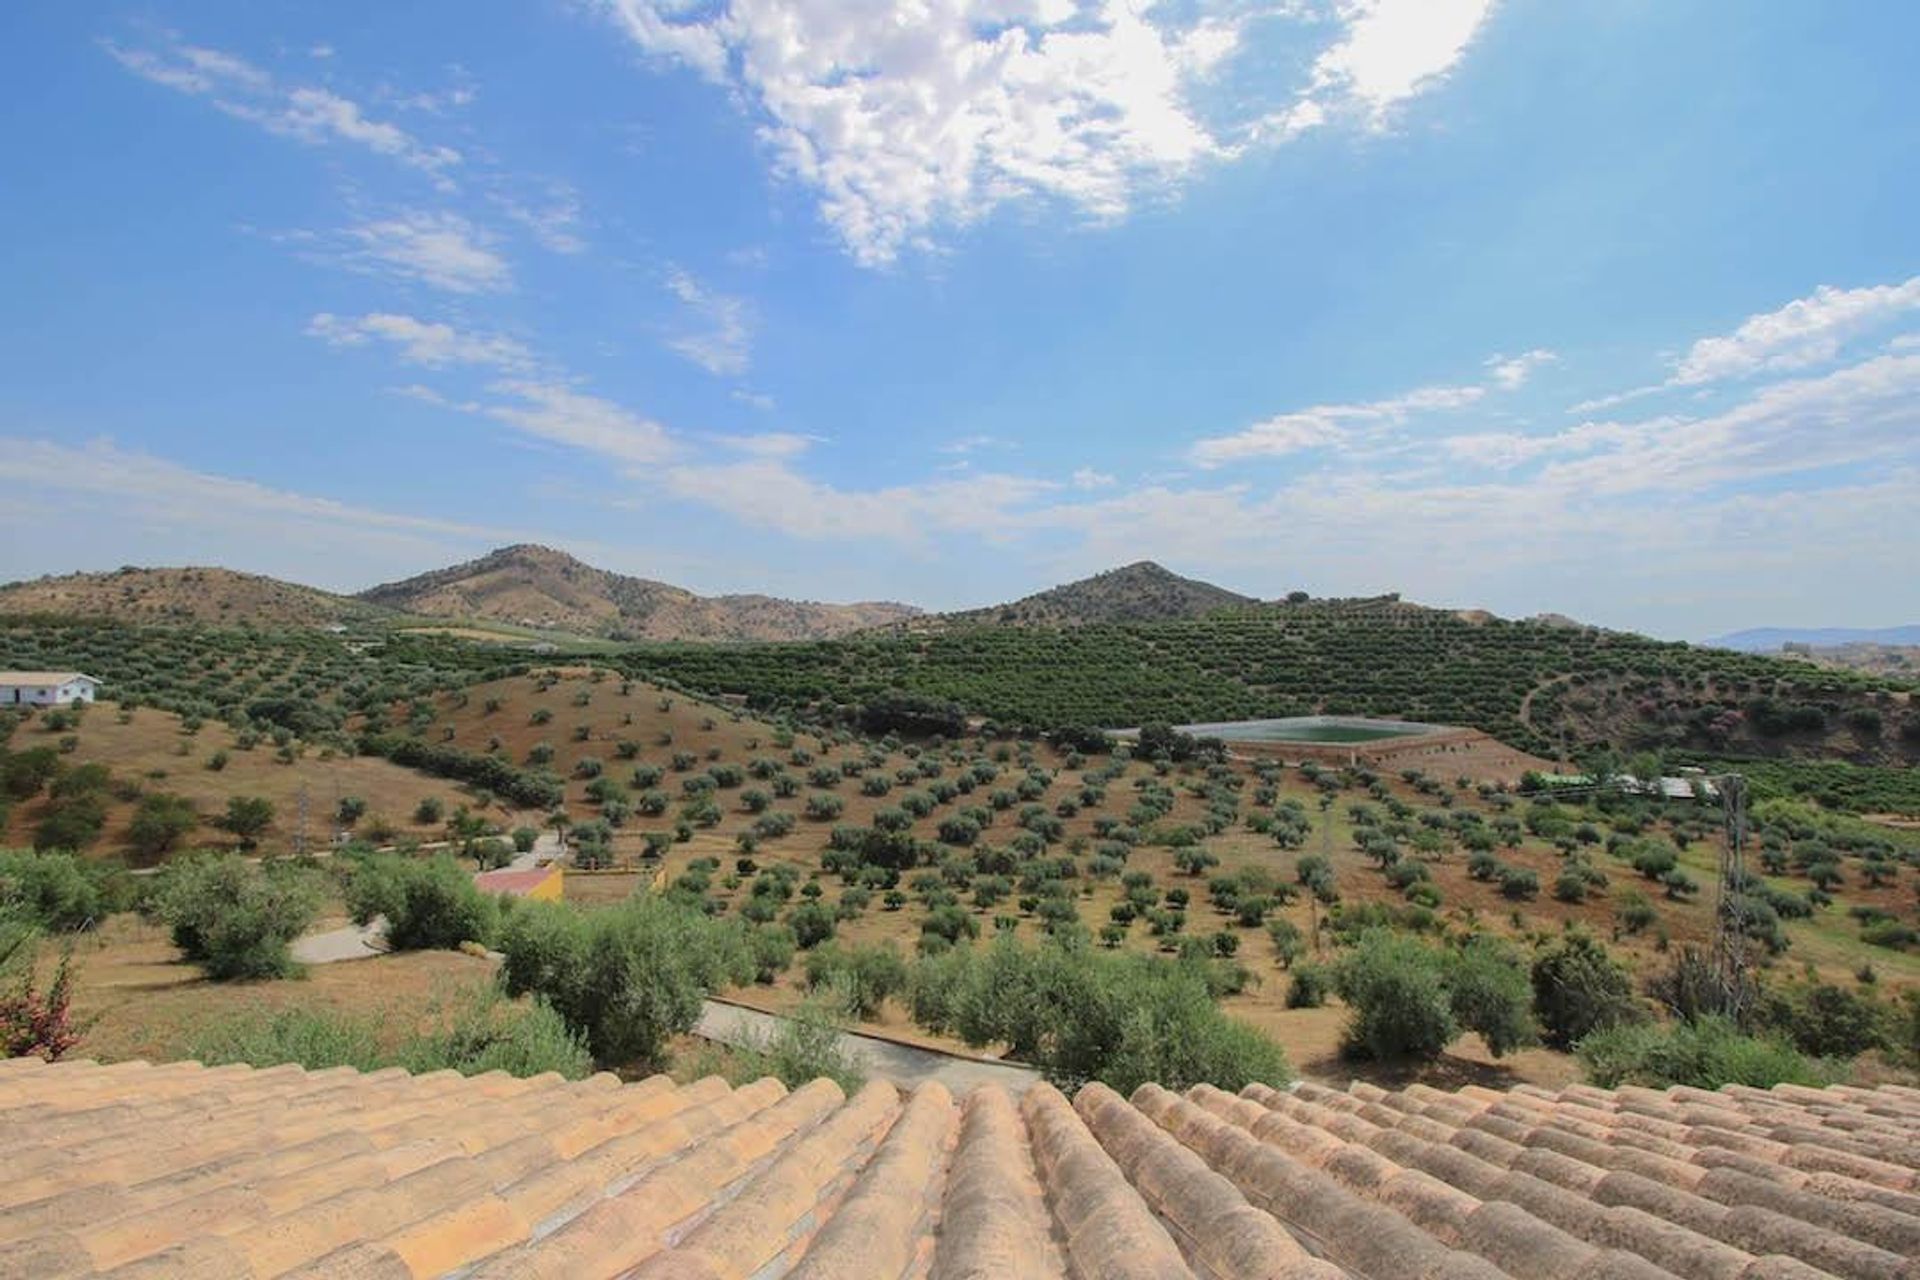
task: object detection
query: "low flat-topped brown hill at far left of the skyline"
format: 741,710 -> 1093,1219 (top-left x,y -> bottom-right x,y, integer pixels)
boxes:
0,566 -> 386,628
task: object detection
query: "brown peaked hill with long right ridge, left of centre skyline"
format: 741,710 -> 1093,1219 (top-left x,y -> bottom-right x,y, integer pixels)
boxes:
359,545 -> 916,641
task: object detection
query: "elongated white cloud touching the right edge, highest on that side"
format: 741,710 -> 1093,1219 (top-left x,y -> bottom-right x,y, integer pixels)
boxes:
1668,276 -> 1920,386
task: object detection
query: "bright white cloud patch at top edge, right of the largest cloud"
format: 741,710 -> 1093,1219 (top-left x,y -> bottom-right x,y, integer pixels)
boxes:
1306,0 -> 1494,127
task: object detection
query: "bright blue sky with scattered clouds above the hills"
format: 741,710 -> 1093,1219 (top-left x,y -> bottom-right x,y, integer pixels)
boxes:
0,0 -> 1920,637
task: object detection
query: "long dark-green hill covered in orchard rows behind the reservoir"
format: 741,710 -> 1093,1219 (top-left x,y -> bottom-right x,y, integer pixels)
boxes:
626,597 -> 1920,764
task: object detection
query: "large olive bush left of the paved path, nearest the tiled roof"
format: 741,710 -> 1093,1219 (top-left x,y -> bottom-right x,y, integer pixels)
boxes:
499,896 -> 753,1069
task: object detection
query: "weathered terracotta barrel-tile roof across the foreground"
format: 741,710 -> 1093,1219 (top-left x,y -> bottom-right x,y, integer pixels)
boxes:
0,1059 -> 1920,1280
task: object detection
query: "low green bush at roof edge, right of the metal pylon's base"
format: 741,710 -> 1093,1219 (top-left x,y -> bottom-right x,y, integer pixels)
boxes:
1574,1017 -> 1832,1088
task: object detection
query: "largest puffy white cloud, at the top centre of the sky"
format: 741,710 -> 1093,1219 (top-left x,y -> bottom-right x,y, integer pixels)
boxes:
605,0 -> 1240,265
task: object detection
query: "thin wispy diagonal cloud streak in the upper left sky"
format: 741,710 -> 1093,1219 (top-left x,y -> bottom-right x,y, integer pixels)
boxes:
106,36 -> 461,175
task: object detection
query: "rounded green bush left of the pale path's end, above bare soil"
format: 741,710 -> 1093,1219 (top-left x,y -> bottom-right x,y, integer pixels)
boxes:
148,854 -> 321,981
